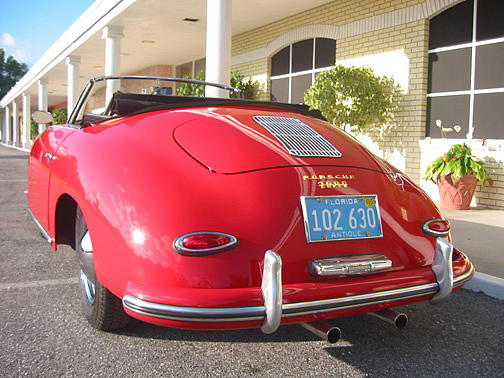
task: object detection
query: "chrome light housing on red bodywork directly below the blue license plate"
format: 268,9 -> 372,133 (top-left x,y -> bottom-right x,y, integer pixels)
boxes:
310,253 -> 392,276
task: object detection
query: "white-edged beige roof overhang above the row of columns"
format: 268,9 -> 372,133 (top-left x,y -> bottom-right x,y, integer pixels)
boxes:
0,0 -> 329,107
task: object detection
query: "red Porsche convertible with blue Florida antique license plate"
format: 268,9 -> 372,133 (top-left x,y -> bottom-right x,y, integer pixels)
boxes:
27,76 -> 474,341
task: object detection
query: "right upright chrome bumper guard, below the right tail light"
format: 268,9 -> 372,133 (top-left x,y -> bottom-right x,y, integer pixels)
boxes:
431,238 -> 453,302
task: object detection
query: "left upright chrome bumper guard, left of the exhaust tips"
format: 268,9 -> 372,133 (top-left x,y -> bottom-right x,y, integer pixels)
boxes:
261,251 -> 282,333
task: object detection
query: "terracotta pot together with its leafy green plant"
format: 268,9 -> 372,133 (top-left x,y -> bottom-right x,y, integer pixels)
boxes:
425,144 -> 492,210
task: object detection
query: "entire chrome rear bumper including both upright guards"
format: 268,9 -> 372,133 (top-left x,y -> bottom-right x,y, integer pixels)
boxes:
123,238 -> 474,333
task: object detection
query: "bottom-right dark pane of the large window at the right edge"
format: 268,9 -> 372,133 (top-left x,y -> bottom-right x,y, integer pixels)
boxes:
473,93 -> 504,139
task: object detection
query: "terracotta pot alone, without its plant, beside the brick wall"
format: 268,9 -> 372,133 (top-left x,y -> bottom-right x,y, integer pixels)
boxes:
437,175 -> 478,210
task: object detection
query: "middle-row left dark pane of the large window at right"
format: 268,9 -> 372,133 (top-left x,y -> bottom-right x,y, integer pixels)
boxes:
428,47 -> 471,93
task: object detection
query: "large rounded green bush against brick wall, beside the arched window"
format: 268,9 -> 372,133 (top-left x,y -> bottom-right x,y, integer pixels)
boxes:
304,65 -> 401,129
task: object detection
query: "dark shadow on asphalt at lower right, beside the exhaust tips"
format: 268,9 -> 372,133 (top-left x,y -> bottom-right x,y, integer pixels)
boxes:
325,290 -> 504,377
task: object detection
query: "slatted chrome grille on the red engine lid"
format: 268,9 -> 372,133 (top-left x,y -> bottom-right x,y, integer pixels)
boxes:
254,116 -> 341,157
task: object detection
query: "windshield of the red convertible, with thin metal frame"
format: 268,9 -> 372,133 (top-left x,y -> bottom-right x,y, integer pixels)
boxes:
69,76 -> 240,126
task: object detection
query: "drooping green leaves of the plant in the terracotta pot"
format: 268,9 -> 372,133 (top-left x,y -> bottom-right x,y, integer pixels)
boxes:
424,144 -> 493,186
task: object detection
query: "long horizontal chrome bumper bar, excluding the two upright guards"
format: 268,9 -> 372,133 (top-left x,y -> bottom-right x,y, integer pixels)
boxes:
123,264 -> 474,323
